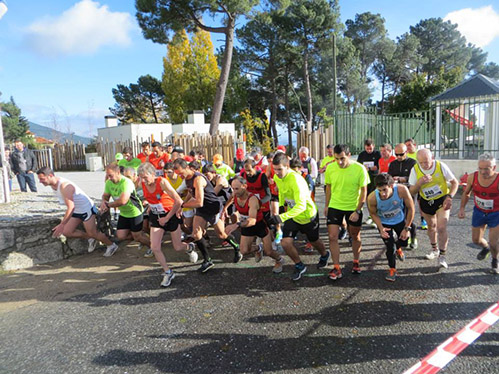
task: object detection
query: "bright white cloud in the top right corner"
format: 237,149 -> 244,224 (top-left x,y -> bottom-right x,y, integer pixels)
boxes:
444,5 -> 499,47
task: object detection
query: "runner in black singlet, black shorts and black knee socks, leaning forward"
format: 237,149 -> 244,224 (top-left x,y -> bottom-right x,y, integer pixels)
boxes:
173,159 -> 243,273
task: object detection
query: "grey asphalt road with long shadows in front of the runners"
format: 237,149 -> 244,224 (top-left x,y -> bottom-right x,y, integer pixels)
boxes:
0,173 -> 499,374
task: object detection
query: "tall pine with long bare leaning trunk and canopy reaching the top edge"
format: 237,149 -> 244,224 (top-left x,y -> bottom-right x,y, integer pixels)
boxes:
135,0 -> 259,135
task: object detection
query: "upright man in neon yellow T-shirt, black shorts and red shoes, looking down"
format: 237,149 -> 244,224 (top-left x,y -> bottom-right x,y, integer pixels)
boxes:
324,144 -> 369,280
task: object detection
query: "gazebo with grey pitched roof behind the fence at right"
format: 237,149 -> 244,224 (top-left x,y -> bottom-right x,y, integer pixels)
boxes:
430,74 -> 499,159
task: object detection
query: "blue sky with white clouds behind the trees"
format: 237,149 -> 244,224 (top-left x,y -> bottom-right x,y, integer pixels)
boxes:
0,0 -> 499,136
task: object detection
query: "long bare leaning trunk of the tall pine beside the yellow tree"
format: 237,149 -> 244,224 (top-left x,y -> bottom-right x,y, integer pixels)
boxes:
210,17 -> 235,135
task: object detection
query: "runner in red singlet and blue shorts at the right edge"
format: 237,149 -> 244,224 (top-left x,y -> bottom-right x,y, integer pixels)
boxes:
458,153 -> 499,274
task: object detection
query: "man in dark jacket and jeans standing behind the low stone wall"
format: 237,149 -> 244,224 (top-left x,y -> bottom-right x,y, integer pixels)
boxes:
9,140 -> 38,192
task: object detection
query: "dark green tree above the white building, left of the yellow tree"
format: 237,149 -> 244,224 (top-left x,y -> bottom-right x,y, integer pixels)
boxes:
109,75 -> 166,123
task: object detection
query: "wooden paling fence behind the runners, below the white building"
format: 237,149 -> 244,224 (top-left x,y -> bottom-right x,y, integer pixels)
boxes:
97,133 -> 245,165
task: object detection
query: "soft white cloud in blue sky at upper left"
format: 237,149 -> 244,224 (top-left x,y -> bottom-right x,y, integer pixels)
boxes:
25,0 -> 136,56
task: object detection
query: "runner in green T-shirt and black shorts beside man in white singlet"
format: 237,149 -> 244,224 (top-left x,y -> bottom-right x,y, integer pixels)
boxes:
99,163 -> 151,256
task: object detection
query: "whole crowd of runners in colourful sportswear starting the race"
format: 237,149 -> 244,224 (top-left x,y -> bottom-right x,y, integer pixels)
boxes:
37,139 -> 499,287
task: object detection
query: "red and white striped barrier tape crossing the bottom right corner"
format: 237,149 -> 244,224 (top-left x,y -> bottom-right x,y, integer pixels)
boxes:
404,302 -> 499,374
